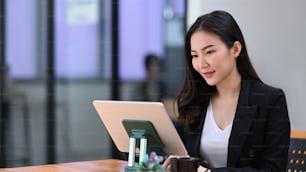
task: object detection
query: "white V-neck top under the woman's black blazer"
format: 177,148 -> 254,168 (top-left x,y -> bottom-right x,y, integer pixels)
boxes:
200,103 -> 232,168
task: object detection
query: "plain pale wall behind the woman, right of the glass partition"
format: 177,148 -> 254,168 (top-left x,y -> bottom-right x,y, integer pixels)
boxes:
187,0 -> 306,130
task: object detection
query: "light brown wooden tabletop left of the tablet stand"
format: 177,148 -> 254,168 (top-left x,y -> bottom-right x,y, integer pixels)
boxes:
0,159 -> 127,172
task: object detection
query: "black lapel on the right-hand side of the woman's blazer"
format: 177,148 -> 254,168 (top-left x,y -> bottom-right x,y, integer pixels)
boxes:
227,80 -> 257,167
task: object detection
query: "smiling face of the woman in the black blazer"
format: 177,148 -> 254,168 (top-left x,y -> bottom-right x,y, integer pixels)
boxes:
190,31 -> 241,86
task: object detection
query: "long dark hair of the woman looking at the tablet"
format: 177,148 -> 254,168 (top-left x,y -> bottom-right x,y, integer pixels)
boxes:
176,11 -> 260,131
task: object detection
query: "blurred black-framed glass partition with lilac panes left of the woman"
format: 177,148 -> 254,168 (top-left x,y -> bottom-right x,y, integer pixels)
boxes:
1,0 -> 186,166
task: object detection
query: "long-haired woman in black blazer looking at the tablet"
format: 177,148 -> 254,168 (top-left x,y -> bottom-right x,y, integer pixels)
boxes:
163,11 -> 290,172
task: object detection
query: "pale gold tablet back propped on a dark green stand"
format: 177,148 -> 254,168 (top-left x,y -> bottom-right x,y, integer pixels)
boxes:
93,100 -> 188,156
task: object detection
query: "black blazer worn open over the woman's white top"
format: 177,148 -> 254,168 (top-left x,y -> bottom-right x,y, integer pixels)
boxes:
177,80 -> 290,172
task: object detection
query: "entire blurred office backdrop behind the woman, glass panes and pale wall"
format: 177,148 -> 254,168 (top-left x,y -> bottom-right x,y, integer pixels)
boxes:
0,0 -> 306,167
